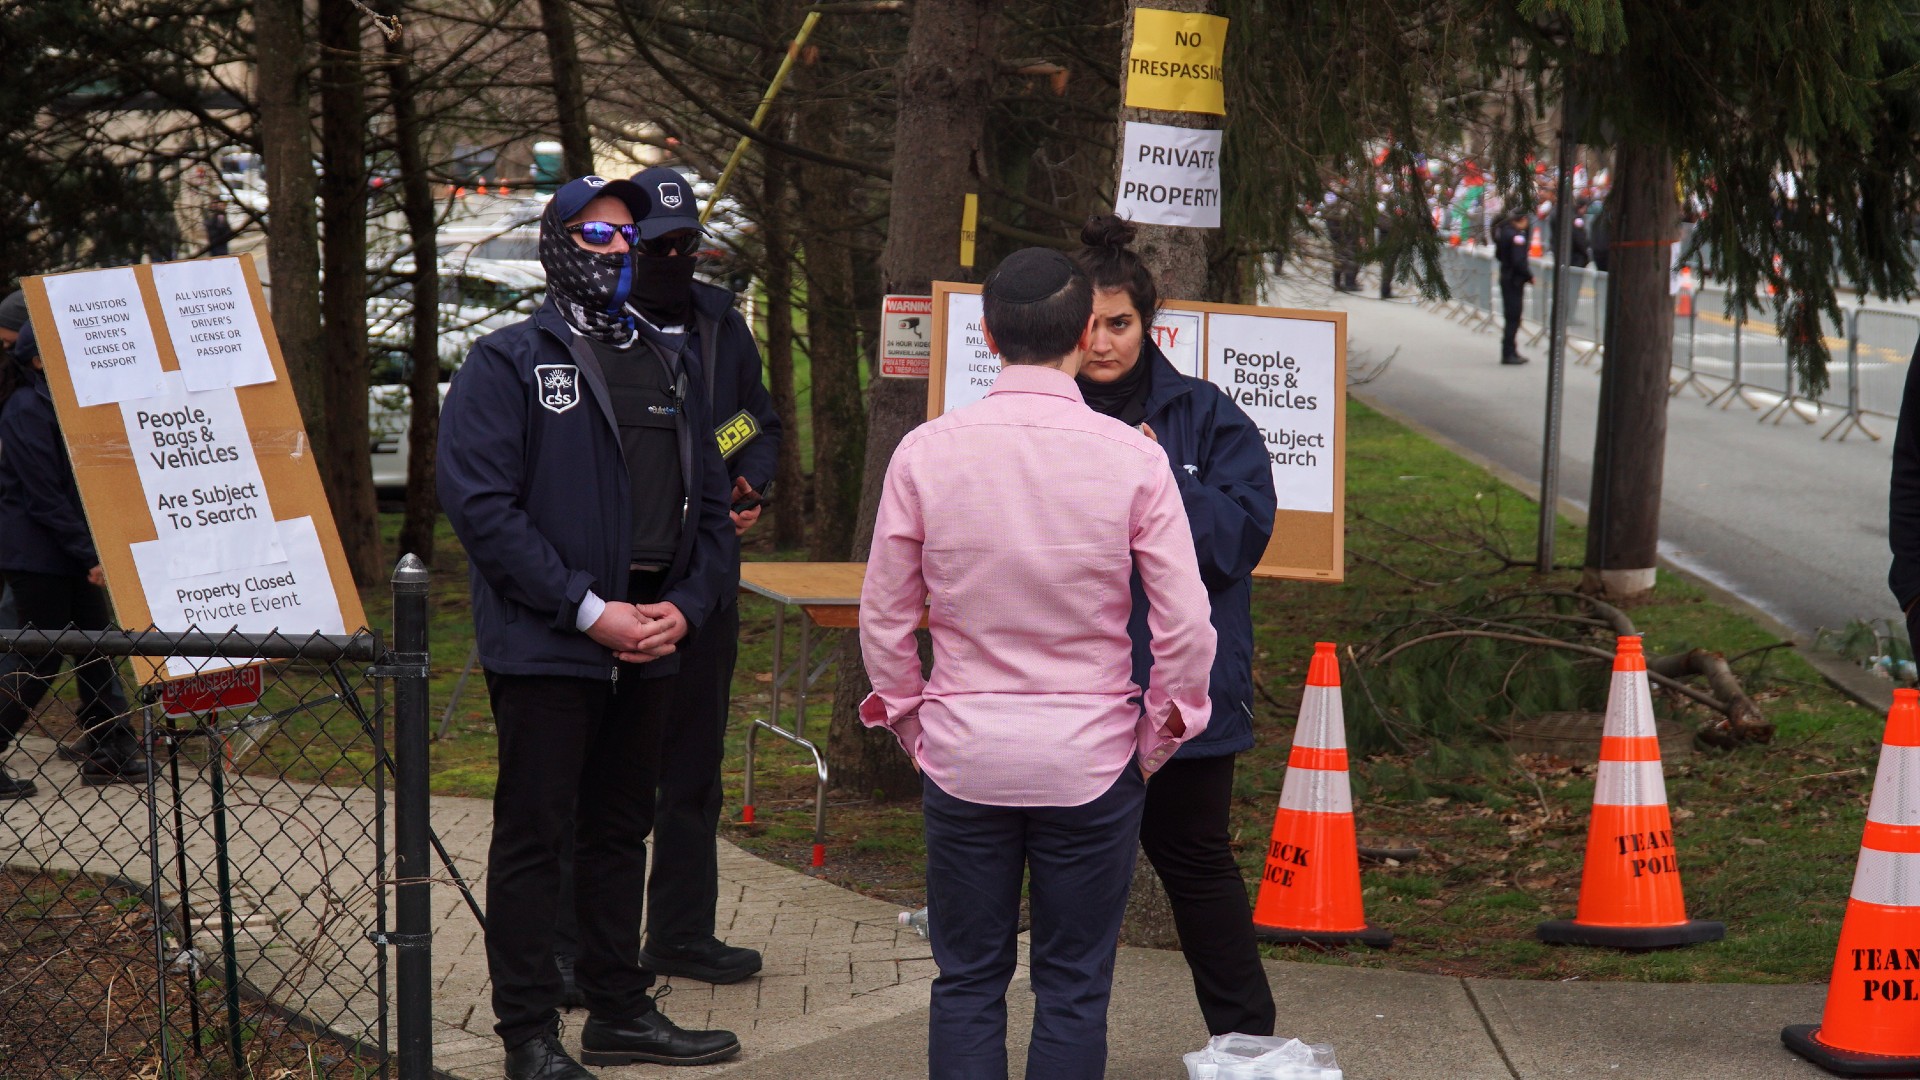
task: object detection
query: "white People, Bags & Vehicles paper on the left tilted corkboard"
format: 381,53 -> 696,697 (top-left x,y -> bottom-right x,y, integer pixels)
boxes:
121,371 -> 286,577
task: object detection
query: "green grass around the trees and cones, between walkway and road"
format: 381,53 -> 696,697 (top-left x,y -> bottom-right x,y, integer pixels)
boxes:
303,402 -> 1884,982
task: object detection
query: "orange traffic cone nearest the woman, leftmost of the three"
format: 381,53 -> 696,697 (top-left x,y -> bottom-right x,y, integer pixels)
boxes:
1254,642 -> 1394,949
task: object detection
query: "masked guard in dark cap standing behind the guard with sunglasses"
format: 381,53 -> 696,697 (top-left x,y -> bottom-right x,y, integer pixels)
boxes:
555,165 -> 780,1003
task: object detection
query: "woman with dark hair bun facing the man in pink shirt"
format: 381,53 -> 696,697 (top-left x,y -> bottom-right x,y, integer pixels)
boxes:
1075,215 -> 1275,1036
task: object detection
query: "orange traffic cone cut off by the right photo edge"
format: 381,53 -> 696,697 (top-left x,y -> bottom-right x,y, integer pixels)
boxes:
1780,690 -> 1920,1076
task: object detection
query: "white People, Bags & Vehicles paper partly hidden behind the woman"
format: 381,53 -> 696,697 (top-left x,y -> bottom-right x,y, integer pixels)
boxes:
1206,315 -> 1340,513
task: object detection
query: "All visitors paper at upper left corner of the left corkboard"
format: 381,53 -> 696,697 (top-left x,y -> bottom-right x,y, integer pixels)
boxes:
46,267 -> 161,407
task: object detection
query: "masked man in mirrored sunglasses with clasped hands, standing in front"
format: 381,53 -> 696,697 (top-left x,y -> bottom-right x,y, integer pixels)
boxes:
440,177 -> 739,1080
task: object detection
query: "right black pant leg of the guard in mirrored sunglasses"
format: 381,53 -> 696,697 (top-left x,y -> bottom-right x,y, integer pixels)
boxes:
574,665 -> 676,1020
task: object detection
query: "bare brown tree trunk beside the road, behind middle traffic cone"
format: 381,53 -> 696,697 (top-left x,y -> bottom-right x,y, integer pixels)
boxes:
1584,142 -> 1680,600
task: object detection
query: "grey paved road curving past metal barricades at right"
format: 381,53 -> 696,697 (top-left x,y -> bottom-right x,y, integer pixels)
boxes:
1269,272 -> 1897,636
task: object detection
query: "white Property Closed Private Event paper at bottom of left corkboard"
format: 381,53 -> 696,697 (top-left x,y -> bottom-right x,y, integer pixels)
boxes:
132,517 -> 348,678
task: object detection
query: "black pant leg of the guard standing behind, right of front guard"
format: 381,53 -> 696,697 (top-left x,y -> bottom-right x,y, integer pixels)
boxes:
647,603 -> 739,945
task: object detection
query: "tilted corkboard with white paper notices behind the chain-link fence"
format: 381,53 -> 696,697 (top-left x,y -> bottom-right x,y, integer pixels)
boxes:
21,258 -> 367,680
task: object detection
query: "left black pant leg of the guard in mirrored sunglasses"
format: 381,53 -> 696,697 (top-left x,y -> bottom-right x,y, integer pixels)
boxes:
486,673 -> 614,1047
